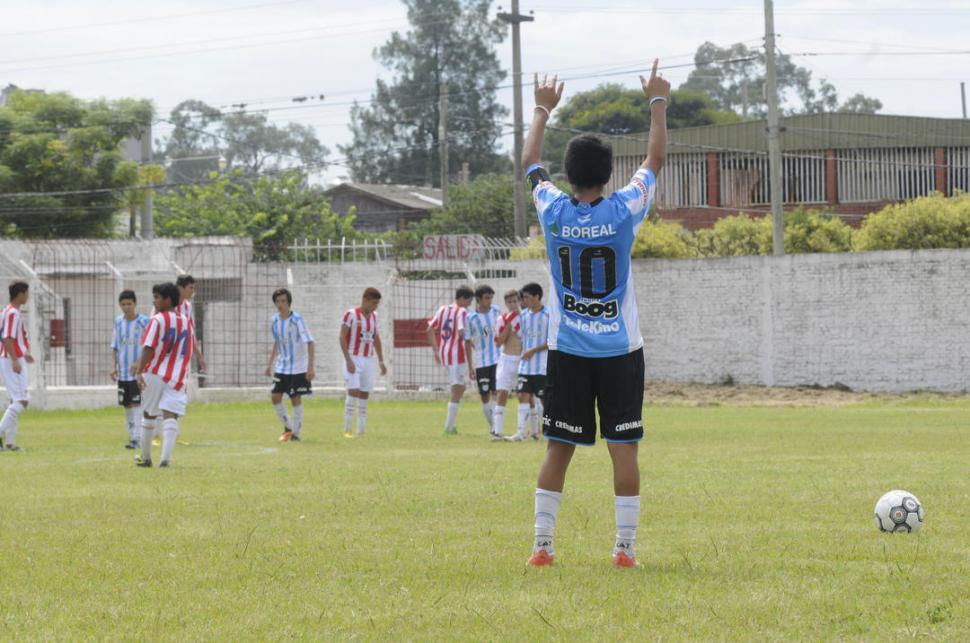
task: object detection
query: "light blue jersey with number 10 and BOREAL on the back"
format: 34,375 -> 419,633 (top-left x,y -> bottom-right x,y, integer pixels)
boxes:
528,165 -> 657,357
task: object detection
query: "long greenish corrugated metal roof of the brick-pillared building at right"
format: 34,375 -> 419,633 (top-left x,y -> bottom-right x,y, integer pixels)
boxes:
612,114 -> 970,156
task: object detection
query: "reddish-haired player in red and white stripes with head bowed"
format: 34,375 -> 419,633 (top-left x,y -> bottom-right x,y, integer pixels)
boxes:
340,288 -> 387,438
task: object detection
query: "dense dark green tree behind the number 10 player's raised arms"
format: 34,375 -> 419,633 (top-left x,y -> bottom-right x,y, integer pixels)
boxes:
544,83 -> 741,173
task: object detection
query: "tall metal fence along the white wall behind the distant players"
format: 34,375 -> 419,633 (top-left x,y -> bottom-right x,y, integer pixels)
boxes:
0,236 -> 546,402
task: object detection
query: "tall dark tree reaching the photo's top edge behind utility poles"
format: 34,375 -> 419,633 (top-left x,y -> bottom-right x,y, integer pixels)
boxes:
340,0 -> 509,186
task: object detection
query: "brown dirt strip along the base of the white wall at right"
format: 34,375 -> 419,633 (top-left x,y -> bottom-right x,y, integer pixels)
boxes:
646,382 -> 965,406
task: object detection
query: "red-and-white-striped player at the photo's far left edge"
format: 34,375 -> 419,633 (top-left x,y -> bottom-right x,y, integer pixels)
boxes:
0,281 -> 34,451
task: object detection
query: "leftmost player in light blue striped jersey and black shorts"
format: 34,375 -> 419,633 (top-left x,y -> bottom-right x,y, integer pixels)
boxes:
111,290 -> 148,449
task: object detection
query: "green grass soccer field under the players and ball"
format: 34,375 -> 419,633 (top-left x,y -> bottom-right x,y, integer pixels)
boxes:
0,398 -> 970,640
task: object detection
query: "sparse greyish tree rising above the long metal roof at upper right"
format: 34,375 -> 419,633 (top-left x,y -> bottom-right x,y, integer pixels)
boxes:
681,42 -> 882,118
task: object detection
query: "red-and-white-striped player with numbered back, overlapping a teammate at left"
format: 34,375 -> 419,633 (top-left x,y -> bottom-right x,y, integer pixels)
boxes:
135,283 -> 195,467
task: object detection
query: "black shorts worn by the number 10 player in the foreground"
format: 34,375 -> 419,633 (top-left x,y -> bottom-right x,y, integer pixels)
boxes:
542,348 -> 643,445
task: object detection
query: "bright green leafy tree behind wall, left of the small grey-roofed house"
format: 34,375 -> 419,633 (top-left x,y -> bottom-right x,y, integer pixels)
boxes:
155,169 -> 365,256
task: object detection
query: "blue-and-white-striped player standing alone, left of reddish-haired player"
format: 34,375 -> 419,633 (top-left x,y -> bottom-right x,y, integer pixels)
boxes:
266,288 -> 314,442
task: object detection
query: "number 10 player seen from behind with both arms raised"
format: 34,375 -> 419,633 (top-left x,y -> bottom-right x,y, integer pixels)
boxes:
522,60 -> 670,567
